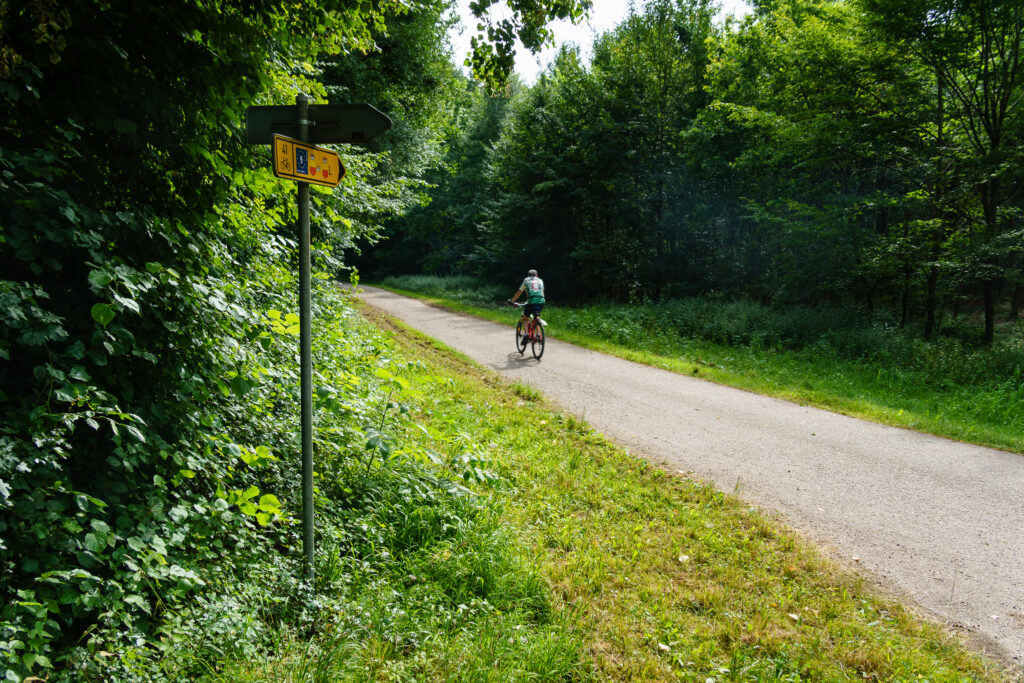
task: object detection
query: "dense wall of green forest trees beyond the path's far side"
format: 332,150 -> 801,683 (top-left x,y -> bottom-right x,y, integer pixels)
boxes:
361,0 -> 1024,342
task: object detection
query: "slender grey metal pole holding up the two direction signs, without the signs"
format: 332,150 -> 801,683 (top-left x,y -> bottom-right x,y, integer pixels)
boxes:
295,93 -> 314,582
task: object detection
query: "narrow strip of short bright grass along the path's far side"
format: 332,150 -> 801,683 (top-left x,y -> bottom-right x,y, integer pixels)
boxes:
370,286 -> 1024,454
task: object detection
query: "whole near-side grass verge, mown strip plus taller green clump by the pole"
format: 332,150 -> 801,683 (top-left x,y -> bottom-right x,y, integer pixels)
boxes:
199,296 -> 1013,683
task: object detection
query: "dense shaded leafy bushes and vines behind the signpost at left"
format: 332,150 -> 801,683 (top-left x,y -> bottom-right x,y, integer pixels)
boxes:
0,0 -> 468,680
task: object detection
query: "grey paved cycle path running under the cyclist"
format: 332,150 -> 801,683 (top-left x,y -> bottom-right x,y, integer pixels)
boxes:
359,287 -> 1024,667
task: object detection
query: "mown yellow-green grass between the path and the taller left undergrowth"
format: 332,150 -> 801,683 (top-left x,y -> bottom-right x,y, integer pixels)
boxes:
286,305 -> 1011,682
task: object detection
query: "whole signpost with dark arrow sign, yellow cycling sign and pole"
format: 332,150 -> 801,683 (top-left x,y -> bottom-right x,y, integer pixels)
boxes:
246,93 -> 391,582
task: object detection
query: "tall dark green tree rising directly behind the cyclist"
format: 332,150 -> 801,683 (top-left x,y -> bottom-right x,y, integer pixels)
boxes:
466,2 -> 711,298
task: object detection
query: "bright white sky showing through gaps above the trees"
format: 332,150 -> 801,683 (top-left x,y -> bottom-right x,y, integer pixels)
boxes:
450,0 -> 751,84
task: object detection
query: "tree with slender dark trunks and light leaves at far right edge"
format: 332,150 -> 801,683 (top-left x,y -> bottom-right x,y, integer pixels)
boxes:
864,0 -> 1024,344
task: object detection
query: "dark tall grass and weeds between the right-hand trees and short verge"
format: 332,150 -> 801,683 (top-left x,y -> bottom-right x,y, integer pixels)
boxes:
561,299 -> 1024,430
